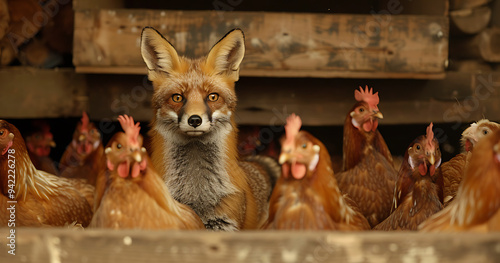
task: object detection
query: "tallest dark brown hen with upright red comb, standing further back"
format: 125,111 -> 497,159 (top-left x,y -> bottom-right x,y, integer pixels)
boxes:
336,87 -> 397,227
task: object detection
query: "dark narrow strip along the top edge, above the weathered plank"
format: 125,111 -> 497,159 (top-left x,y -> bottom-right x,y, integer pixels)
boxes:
74,0 -> 448,15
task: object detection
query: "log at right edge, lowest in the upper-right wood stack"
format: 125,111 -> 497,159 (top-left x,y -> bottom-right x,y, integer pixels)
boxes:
450,28 -> 500,62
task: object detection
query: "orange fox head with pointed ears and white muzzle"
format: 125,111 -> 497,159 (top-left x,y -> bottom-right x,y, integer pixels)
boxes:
141,27 -> 245,138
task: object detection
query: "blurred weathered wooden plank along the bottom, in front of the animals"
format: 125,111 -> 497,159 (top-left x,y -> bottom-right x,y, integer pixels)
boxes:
0,228 -> 500,263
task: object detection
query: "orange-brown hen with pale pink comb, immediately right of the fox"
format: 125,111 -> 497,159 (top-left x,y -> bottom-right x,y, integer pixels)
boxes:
264,114 -> 370,230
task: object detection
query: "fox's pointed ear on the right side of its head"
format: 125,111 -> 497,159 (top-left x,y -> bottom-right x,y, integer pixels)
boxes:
207,28 -> 245,81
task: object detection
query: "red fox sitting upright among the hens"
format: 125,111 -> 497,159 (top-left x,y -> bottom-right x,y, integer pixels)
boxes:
141,27 -> 280,231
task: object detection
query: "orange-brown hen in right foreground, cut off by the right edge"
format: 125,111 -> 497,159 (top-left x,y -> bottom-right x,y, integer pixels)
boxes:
419,131 -> 500,232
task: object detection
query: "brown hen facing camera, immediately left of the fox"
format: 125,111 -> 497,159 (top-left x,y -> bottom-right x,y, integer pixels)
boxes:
91,115 -> 205,229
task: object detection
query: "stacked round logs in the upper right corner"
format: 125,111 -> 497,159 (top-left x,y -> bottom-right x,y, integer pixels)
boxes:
450,0 -> 500,72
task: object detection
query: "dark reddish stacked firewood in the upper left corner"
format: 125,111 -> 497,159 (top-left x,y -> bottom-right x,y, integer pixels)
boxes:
0,0 -> 74,68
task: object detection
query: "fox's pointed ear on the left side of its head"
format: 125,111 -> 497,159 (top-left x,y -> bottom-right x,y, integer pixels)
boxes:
141,27 -> 180,74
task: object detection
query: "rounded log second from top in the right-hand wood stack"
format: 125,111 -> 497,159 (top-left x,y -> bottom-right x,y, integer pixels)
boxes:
450,6 -> 491,35
